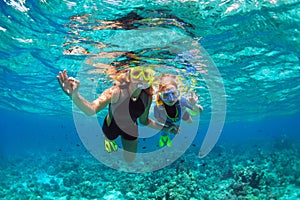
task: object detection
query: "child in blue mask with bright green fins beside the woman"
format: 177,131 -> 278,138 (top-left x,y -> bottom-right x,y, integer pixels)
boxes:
154,75 -> 203,147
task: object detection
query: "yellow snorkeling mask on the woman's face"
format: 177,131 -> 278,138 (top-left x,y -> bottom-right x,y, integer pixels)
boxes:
130,67 -> 154,89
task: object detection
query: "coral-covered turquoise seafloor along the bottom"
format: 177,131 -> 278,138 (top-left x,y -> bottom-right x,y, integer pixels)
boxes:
0,139 -> 300,200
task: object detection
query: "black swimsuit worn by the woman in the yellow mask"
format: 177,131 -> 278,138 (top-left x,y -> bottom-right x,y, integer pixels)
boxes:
102,90 -> 149,140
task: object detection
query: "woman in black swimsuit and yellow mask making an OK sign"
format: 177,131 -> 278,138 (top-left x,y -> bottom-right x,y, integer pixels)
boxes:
57,67 -> 175,162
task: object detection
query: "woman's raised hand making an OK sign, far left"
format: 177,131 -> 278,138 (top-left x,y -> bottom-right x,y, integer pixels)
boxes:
56,69 -> 80,97
